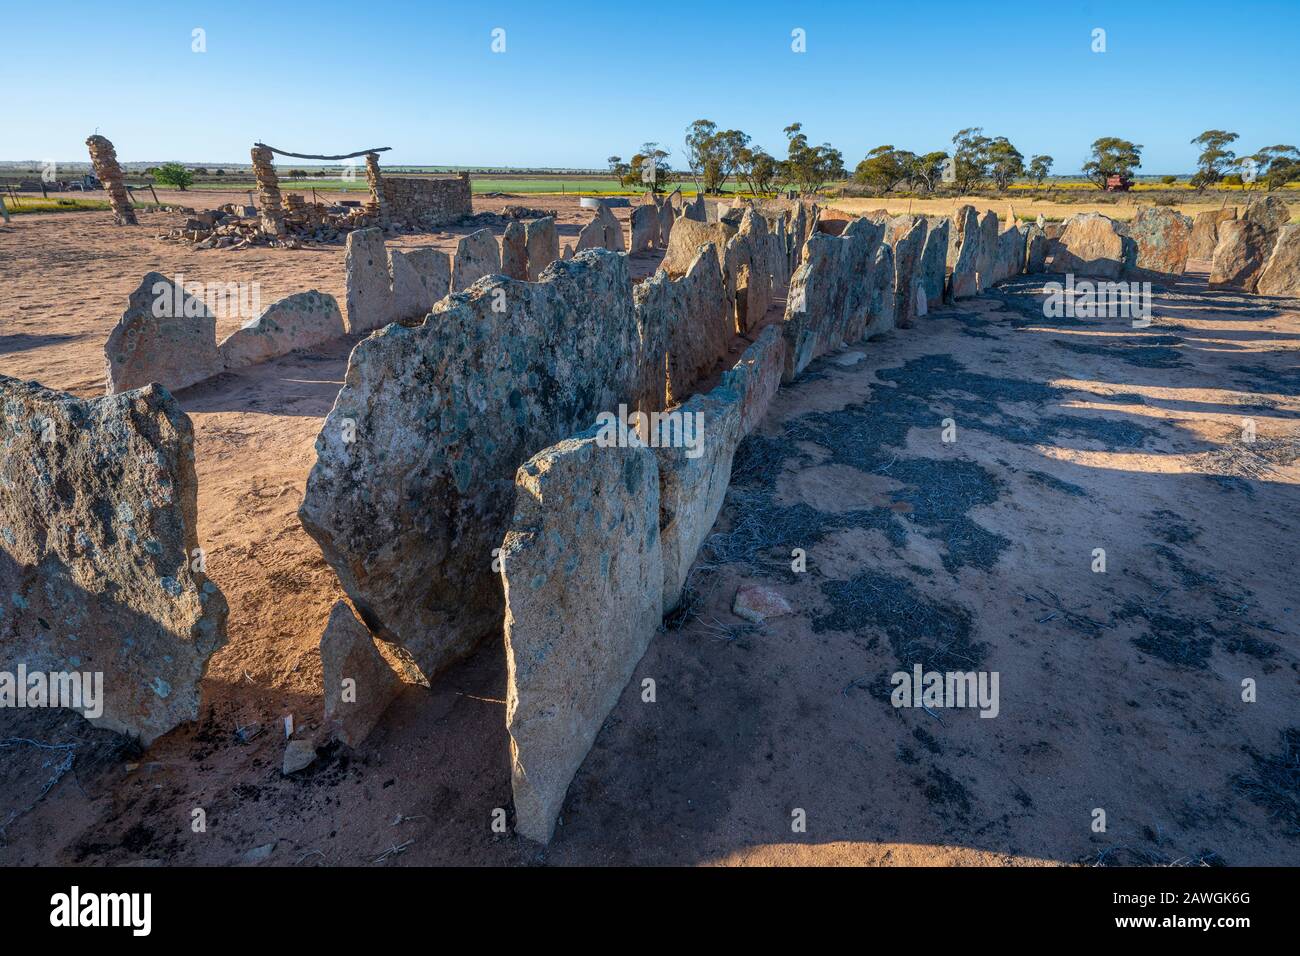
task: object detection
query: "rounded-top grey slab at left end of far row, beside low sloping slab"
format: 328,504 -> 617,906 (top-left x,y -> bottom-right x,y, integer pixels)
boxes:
104,272 -> 225,395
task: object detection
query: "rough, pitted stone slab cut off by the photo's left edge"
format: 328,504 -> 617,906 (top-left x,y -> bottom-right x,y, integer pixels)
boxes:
0,376 -> 226,745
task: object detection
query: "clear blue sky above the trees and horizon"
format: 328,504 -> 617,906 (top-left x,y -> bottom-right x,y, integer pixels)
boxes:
0,0 -> 1300,174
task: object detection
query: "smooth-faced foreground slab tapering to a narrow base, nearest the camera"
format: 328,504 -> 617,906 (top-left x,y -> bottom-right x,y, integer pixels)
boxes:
502,429 -> 663,843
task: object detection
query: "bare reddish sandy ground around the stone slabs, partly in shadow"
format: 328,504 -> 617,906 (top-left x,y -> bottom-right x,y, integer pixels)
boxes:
0,209 -> 1300,865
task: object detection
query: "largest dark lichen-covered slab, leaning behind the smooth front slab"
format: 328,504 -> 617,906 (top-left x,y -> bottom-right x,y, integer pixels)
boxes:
299,251 -> 647,676
